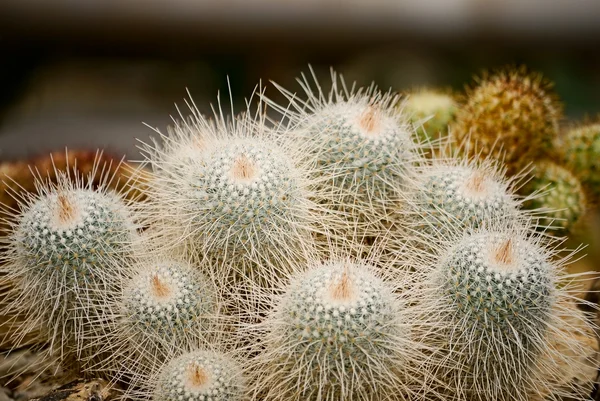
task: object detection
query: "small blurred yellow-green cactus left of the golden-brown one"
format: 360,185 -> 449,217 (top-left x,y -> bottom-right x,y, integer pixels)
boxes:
401,89 -> 458,143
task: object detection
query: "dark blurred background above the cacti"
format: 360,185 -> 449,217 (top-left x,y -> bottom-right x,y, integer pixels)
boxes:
0,0 -> 600,160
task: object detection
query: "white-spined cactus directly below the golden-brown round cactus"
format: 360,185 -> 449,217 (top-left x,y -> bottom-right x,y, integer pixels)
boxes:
404,158 -> 522,239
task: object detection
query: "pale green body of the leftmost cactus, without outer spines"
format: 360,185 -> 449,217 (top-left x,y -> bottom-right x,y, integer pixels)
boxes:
16,189 -> 133,286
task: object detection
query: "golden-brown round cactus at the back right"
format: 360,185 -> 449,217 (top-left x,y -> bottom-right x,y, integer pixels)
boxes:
451,68 -> 561,174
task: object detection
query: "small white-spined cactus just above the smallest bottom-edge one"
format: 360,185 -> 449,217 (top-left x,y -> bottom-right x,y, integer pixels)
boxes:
87,255 -> 220,378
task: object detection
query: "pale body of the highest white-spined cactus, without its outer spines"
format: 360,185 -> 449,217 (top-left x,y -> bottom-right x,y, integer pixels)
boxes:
302,100 -> 415,201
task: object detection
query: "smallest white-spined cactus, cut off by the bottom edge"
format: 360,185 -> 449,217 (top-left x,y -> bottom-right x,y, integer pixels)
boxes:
152,351 -> 246,401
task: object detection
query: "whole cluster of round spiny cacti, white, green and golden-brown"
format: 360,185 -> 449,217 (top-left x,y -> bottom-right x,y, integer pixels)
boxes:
1,65 -> 595,401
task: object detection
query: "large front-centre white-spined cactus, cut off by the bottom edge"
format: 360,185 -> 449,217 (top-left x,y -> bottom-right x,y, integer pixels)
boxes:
248,261 -> 418,401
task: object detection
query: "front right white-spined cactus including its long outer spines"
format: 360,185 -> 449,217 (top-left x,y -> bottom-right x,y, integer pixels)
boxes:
422,226 -> 587,400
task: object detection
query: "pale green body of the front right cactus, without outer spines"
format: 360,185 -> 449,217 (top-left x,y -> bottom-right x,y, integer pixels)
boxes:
432,230 -> 557,400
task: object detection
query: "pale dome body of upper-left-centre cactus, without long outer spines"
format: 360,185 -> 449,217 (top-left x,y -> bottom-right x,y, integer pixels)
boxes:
185,140 -> 302,246
